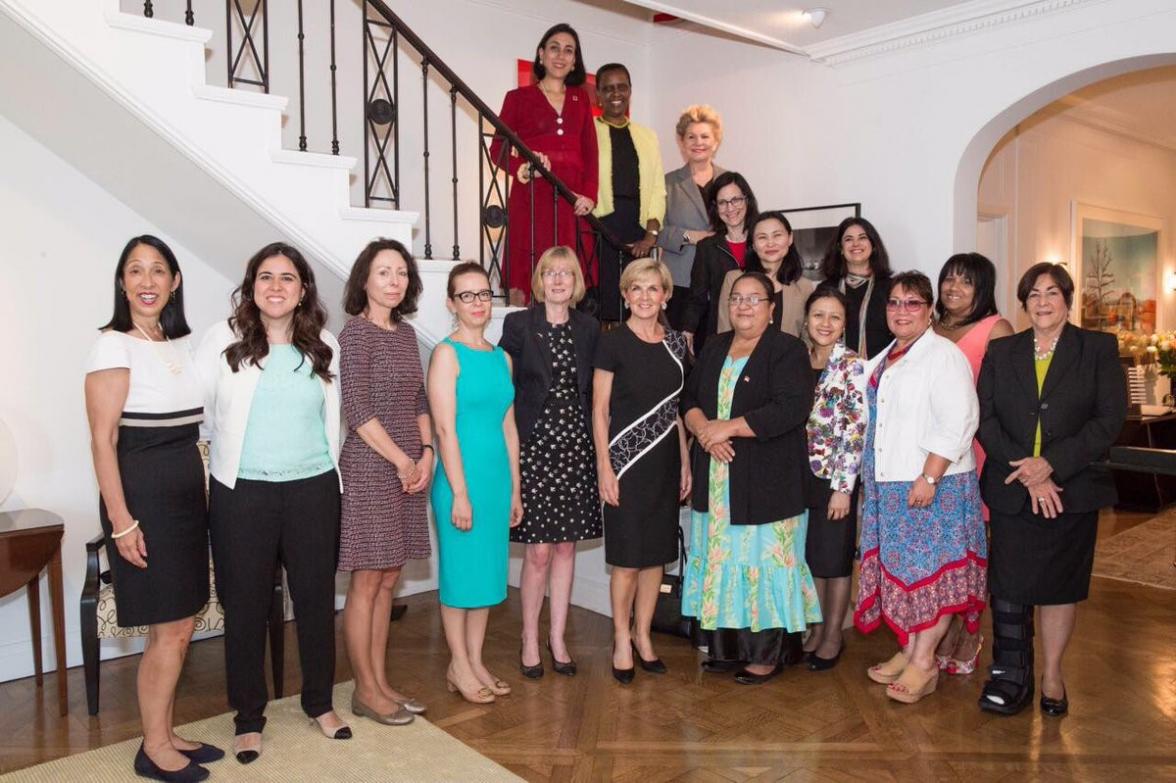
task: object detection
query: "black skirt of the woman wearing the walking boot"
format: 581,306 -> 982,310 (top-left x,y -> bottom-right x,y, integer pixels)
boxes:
988,498 -> 1098,605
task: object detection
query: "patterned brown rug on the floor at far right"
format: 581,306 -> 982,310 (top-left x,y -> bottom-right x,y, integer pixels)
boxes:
1094,508 -> 1176,590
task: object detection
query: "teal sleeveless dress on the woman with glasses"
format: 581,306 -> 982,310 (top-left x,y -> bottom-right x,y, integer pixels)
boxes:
430,337 -> 514,609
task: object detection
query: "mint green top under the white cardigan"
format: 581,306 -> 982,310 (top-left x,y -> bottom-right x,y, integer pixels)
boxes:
236,346 -> 334,481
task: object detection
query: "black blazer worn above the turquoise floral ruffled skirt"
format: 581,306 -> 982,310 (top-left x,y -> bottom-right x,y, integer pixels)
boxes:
681,329 -> 813,524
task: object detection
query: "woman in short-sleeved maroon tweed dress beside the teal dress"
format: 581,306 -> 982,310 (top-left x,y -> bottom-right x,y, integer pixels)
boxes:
339,239 -> 433,725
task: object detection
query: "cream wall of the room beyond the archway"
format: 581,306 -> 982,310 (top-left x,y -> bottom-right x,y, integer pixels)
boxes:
980,106 -> 1176,329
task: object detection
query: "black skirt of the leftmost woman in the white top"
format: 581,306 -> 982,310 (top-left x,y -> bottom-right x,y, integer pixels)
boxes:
99,418 -> 208,628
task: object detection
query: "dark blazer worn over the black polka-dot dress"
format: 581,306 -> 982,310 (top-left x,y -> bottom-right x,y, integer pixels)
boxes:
499,303 -> 600,441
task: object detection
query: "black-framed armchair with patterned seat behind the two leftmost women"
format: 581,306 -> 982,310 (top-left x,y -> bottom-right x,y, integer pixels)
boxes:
78,442 -> 286,715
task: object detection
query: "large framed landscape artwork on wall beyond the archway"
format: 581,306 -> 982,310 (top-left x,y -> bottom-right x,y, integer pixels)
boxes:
1070,201 -> 1164,334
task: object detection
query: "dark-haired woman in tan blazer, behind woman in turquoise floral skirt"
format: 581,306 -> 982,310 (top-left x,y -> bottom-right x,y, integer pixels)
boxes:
719,210 -> 816,337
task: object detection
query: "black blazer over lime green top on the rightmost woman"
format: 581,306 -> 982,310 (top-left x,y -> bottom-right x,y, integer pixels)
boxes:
976,323 -> 1127,514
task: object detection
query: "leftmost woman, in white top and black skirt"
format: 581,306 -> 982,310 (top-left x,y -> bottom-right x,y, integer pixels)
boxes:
86,235 -> 225,781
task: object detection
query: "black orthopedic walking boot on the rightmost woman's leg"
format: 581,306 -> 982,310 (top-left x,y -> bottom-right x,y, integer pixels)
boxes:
980,596 -> 1034,715
